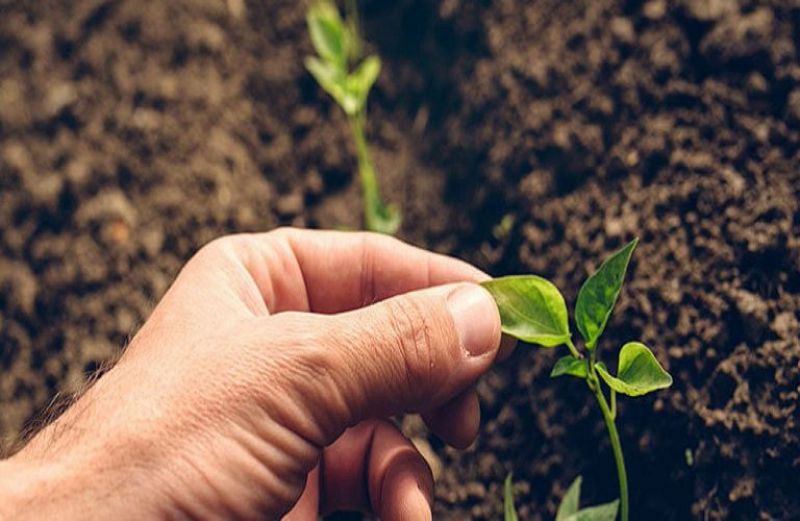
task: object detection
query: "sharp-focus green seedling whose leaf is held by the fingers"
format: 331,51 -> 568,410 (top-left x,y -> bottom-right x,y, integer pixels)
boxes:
483,240 -> 672,521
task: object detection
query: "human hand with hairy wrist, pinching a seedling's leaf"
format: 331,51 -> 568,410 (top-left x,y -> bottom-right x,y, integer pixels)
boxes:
0,229 -> 510,521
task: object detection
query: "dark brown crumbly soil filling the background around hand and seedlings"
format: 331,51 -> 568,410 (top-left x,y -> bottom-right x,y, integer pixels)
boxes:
0,0 -> 800,520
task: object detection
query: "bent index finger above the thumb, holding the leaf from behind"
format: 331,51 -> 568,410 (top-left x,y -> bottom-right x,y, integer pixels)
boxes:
239,228 -> 489,313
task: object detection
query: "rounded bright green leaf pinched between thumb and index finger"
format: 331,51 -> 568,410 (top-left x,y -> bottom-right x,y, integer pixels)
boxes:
482,275 -> 570,347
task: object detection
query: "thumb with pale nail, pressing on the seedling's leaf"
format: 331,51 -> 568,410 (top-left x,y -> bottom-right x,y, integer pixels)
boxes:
309,283 -> 500,428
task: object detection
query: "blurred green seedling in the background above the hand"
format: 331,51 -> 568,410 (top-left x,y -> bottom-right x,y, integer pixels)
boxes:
305,0 -> 401,234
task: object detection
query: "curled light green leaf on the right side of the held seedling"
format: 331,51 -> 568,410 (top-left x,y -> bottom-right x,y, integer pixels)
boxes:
595,342 -> 672,396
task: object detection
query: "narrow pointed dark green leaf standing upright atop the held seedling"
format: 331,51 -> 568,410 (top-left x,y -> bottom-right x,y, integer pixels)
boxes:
575,239 -> 639,349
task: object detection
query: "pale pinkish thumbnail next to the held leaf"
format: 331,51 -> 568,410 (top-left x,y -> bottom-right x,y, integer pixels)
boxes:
447,284 -> 500,356
